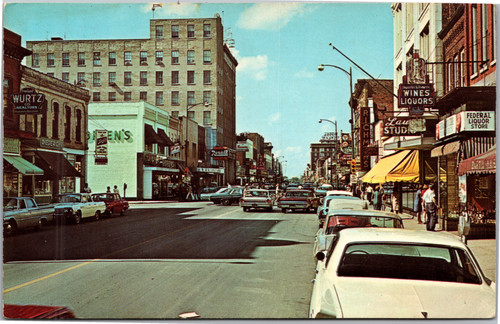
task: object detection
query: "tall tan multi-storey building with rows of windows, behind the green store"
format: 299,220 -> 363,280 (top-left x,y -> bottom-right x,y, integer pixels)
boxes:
26,15 -> 238,185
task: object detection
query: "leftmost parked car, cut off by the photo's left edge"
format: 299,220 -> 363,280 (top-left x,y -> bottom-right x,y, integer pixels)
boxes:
3,197 -> 54,235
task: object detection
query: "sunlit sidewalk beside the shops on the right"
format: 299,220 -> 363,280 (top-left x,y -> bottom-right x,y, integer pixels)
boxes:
400,213 -> 497,282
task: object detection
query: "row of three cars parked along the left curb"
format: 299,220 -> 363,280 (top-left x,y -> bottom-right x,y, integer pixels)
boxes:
3,193 -> 129,234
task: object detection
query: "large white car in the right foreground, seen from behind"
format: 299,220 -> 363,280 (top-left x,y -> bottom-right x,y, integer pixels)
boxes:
309,227 -> 496,319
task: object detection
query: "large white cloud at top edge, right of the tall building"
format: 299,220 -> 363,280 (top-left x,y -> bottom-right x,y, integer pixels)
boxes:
238,2 -> 305,30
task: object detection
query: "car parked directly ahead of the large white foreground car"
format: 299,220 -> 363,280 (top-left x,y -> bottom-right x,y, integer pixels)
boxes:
313,209 -> 404,256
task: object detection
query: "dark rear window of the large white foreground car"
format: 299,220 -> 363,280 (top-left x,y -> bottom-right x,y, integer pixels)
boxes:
337,242 -> 481,284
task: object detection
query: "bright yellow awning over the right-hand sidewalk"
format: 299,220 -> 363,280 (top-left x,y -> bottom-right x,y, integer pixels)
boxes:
361,150 -> 419,183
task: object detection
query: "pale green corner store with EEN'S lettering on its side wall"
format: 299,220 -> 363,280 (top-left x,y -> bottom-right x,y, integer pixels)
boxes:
87,102 -> 182,200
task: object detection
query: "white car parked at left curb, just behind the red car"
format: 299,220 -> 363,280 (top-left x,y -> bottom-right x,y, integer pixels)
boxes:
54,193 -> 106,224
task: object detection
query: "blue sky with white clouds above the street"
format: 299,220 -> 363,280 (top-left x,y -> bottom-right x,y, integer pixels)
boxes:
3,1 -> 393,177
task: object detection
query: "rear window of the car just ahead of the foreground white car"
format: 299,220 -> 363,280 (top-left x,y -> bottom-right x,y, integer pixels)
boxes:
326,215 -> 403,234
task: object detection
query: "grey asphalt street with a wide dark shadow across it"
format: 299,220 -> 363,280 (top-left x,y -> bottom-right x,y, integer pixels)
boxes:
3,202 -> 317,319
